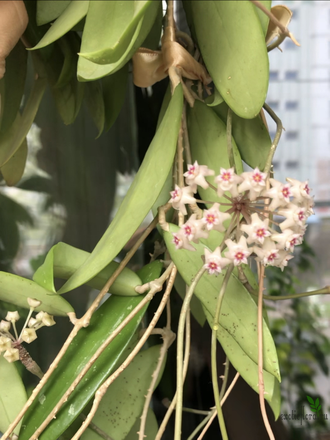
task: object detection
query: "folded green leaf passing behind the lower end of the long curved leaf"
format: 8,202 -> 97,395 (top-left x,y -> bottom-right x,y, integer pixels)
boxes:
33,243 -> 142,296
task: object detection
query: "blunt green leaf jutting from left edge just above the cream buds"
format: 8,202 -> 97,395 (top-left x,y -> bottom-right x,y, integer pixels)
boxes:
0,272 -> 74,316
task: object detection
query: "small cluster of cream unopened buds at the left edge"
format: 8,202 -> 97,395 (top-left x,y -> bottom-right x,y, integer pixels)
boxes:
0,298 -> 55,362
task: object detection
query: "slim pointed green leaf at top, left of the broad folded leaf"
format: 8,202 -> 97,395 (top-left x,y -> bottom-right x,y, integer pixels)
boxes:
30,0 -> 89,50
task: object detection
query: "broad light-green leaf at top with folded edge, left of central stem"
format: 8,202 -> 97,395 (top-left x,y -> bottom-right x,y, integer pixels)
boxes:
80,0 -> 160,64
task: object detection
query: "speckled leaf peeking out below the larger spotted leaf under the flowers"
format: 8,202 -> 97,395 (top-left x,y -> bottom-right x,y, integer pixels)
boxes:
204,307 -> 281,419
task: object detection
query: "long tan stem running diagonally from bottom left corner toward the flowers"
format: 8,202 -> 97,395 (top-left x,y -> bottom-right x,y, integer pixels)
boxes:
2,217 -> 158,440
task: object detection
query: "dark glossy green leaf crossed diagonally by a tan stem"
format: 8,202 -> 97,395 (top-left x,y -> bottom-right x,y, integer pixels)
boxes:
20,295 -> 146,440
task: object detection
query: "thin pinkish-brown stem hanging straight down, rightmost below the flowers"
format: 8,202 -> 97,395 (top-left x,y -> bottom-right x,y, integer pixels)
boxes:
258,266 -> 275,440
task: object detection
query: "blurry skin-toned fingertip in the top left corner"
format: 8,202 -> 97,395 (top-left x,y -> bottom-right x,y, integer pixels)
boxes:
0,0 -> 28,79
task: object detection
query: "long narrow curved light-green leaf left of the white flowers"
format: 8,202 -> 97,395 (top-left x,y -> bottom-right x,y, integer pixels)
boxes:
59,86 -> 183,293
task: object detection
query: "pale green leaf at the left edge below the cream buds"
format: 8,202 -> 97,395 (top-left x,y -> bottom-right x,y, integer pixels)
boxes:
0,355 -> 27,435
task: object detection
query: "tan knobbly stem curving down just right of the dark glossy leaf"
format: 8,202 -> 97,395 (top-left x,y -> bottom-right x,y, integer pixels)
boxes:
71,266 -> 177,440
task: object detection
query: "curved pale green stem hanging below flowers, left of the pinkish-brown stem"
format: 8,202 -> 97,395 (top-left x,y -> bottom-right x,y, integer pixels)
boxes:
211,265 -> 234,440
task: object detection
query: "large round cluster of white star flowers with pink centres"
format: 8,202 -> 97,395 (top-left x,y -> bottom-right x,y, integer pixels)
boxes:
170,162 -> 314,274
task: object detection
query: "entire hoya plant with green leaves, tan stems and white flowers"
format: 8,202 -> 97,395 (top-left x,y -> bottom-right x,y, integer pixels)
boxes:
0,0 -> 328,440
